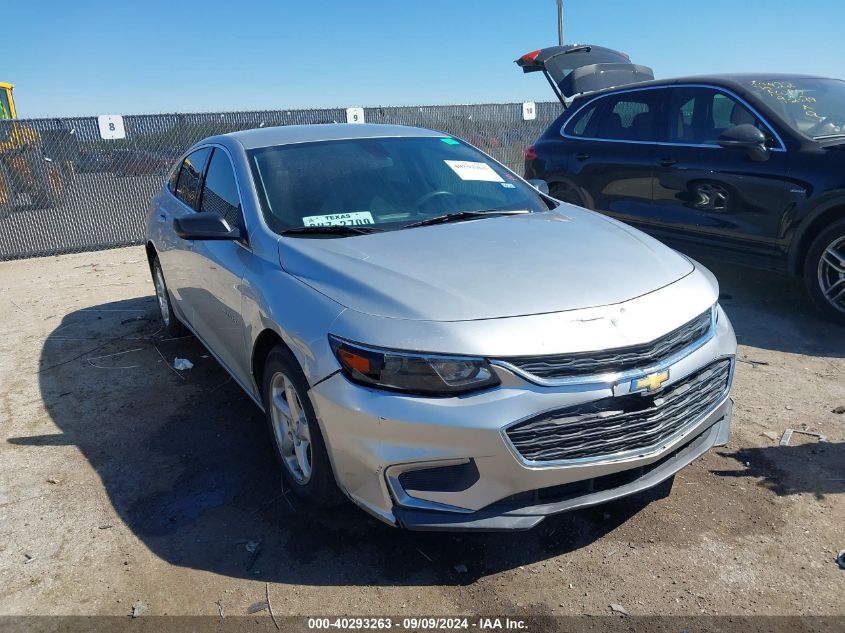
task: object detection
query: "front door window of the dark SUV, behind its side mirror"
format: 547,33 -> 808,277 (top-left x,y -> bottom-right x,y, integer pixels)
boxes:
668,88 -> 773,145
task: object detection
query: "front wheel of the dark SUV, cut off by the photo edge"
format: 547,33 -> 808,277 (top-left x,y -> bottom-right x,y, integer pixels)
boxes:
804,220 -> 845,325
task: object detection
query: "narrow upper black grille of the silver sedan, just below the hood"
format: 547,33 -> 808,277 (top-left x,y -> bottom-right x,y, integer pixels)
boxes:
502,309 -> 712,379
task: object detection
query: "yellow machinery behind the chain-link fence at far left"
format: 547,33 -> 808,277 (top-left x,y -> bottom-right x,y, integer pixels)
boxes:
0,82 -> 73,213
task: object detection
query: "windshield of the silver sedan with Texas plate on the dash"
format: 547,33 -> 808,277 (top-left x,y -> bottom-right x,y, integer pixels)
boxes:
249,138 -> 548,233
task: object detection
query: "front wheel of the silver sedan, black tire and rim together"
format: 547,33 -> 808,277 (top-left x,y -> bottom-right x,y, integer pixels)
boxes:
261,345 -> 344,508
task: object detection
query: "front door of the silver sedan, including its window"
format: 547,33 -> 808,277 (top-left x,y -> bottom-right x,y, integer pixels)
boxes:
185,146 -> 252,384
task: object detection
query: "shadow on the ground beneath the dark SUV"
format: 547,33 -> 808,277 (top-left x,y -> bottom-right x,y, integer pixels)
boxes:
700,257 -> 845,358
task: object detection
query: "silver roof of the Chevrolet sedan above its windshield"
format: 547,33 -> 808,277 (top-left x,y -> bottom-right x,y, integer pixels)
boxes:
214,123 -> 448,149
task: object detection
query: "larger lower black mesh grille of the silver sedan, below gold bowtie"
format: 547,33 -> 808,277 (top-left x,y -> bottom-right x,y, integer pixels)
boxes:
507,359 -> 731,462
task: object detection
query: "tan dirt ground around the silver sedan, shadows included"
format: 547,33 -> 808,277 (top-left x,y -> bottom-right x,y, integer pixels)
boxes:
0,247 -> 845,617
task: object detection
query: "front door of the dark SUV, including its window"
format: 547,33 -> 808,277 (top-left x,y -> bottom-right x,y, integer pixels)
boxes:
642,86 -> 794,255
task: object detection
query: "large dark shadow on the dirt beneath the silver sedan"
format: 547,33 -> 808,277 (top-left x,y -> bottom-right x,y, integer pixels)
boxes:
16,297 -> 668,585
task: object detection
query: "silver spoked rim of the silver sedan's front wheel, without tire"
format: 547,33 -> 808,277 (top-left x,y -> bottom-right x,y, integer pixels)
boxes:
270,372 -> 312,485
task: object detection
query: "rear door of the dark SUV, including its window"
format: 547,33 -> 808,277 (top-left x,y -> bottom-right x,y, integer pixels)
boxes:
546,90 -> 659,221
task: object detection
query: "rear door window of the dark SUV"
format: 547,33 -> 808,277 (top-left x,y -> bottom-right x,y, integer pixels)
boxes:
595,90 -> 661,141
